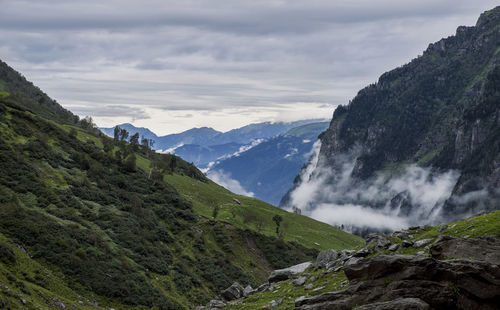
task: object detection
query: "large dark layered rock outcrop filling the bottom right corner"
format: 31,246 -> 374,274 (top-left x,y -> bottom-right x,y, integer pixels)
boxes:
295,255 -> 500,310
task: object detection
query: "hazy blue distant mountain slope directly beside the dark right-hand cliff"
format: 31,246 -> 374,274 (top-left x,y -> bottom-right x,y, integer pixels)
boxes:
208,122 -> 329,205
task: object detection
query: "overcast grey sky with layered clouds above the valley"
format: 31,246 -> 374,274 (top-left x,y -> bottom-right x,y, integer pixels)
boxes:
0,0 -> 498,134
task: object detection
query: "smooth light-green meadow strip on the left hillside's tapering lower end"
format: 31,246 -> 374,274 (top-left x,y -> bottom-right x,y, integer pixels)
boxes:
165,174 -> 363,249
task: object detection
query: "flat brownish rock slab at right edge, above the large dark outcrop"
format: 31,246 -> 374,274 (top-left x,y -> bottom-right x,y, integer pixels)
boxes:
430,236 -> 500,265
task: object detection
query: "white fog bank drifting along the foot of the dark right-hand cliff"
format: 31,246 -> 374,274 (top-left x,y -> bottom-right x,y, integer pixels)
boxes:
285,140 -> 460,233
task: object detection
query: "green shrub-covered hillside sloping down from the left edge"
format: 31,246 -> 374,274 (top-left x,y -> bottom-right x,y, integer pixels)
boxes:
0,63 -> 360,309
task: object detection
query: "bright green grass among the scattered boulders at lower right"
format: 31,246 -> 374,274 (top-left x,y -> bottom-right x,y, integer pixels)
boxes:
225,210 -> 500,310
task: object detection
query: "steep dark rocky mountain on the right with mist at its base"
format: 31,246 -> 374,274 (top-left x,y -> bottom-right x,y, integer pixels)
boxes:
281,7 -> 500,235
